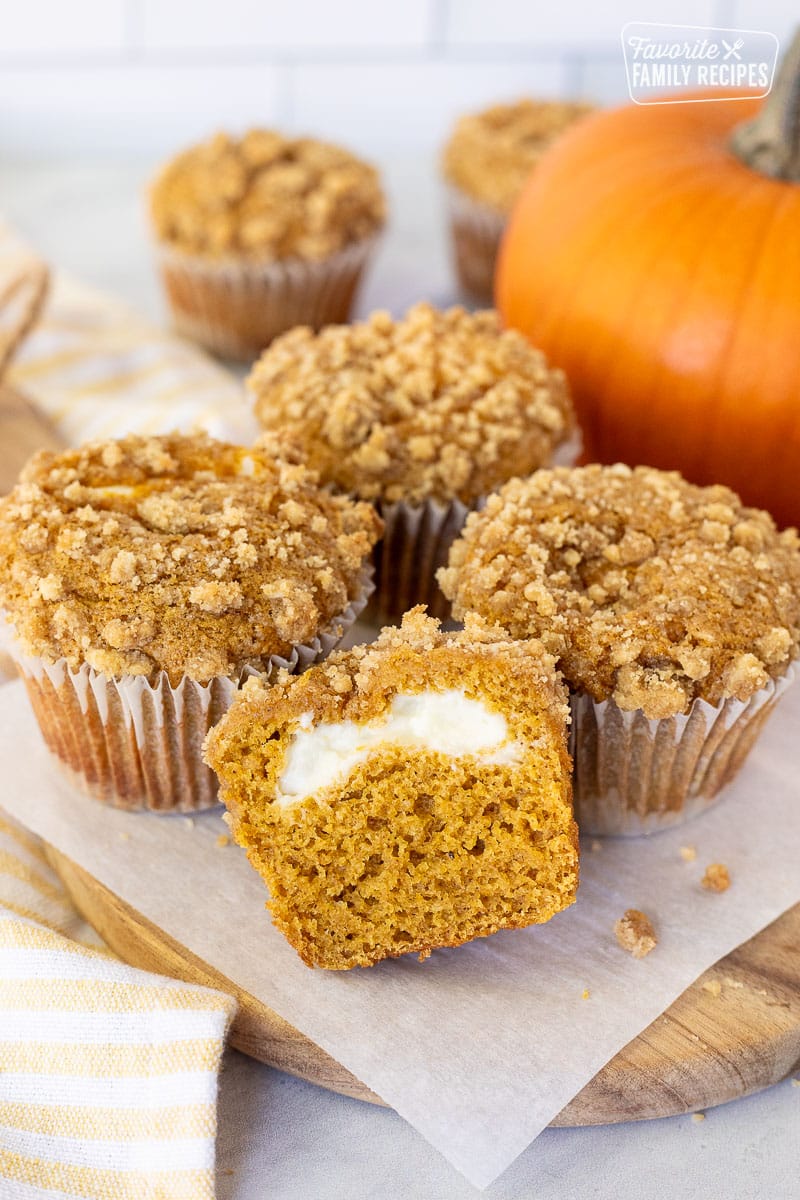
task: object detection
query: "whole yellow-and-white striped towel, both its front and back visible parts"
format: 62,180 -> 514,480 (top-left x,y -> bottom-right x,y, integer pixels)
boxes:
0,222 -> 252,1200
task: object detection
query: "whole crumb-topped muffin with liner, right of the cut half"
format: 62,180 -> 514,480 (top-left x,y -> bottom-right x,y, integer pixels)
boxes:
439,464 -> 800,833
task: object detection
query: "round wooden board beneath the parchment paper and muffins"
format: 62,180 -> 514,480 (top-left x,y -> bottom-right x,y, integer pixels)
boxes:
0,385 -> 800,1126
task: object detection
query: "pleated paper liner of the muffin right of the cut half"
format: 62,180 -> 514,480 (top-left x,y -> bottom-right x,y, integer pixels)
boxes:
570,665 -> 796,836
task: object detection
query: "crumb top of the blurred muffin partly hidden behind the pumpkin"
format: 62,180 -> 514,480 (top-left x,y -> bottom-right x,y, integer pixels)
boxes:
443,98 -> 593,212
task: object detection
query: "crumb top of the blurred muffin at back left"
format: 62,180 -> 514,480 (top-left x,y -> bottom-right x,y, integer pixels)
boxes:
150,130 -> 386,262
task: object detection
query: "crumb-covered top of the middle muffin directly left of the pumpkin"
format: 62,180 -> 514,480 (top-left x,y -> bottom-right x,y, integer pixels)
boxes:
248,304 -> 573,504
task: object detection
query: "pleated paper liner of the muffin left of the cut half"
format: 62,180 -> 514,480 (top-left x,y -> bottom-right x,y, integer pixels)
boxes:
7,569 -> 372,812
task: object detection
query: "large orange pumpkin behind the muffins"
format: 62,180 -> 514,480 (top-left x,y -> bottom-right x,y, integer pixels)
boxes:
497,65 -> 800,524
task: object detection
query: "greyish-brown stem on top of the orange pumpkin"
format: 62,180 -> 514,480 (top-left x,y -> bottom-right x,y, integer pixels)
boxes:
730,30 -> 800,180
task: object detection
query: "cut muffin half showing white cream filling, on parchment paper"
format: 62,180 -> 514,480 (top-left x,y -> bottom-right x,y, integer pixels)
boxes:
206,608 -> 578,970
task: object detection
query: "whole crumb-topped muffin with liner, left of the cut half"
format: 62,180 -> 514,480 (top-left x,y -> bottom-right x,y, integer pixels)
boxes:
0,434 -> 379,810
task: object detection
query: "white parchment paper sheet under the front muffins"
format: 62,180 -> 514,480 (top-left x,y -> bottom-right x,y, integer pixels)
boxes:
0,684 -> 800,1187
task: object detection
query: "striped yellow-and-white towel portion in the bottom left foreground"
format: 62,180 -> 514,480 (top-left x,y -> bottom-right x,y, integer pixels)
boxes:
0,816 -> 235,1200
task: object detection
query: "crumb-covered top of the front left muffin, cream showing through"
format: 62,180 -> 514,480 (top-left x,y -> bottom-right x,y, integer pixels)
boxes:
0,433 -> 380,683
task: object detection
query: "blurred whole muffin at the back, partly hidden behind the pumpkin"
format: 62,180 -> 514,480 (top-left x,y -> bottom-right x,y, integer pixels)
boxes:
441,98 -> 593,304
